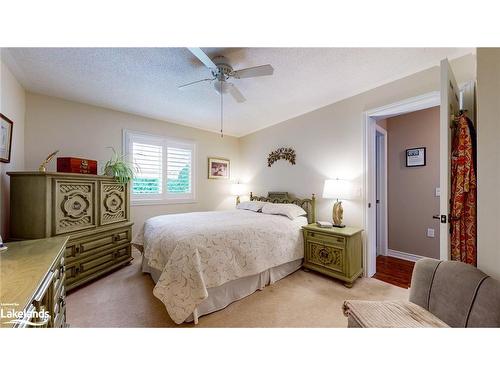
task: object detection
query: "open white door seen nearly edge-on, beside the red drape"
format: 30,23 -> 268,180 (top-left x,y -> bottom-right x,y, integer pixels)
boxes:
439,59 -> 460,260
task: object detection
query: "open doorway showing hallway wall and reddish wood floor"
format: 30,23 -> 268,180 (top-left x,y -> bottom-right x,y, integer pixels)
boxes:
374,106 -> 440,288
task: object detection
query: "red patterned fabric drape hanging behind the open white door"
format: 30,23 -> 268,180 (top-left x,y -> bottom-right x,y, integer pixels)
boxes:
450,114 -> 477,265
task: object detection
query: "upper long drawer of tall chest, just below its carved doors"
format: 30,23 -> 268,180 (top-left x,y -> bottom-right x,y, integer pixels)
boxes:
66,227 -> 132,264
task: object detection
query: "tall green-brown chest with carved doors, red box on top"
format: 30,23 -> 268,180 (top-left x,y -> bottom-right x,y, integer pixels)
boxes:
7,172 -> 133,290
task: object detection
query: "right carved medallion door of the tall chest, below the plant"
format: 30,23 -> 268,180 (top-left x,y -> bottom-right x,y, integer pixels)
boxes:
99,182 -> 129,225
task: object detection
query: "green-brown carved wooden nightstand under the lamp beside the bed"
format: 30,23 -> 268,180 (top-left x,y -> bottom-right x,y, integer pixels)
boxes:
302,224 -> 363,288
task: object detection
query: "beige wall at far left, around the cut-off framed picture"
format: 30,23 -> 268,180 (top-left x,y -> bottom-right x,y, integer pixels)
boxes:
0,55 -> 25,239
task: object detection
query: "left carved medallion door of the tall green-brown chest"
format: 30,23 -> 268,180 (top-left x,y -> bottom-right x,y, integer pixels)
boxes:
52,179 -> 96,235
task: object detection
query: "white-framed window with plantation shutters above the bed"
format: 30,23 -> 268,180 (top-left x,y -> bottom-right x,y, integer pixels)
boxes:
124,130 -> 195,204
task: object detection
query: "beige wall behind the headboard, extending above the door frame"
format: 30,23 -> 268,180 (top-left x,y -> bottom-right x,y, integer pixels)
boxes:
240,55 -> 475,227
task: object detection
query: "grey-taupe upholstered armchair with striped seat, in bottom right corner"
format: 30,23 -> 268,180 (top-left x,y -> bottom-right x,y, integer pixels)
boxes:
343,258 -> 500,328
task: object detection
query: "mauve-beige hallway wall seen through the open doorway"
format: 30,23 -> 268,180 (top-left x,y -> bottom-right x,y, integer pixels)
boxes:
387,107 -> 440,259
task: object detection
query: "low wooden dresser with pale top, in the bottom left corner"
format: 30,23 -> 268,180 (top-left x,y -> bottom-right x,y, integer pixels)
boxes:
0,236 -> 69,328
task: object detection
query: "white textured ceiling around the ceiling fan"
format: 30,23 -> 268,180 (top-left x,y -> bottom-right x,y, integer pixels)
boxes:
3,48 -> 473,136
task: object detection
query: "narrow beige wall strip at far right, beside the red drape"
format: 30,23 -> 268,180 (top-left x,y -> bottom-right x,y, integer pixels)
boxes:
477,48 -> 500,280
